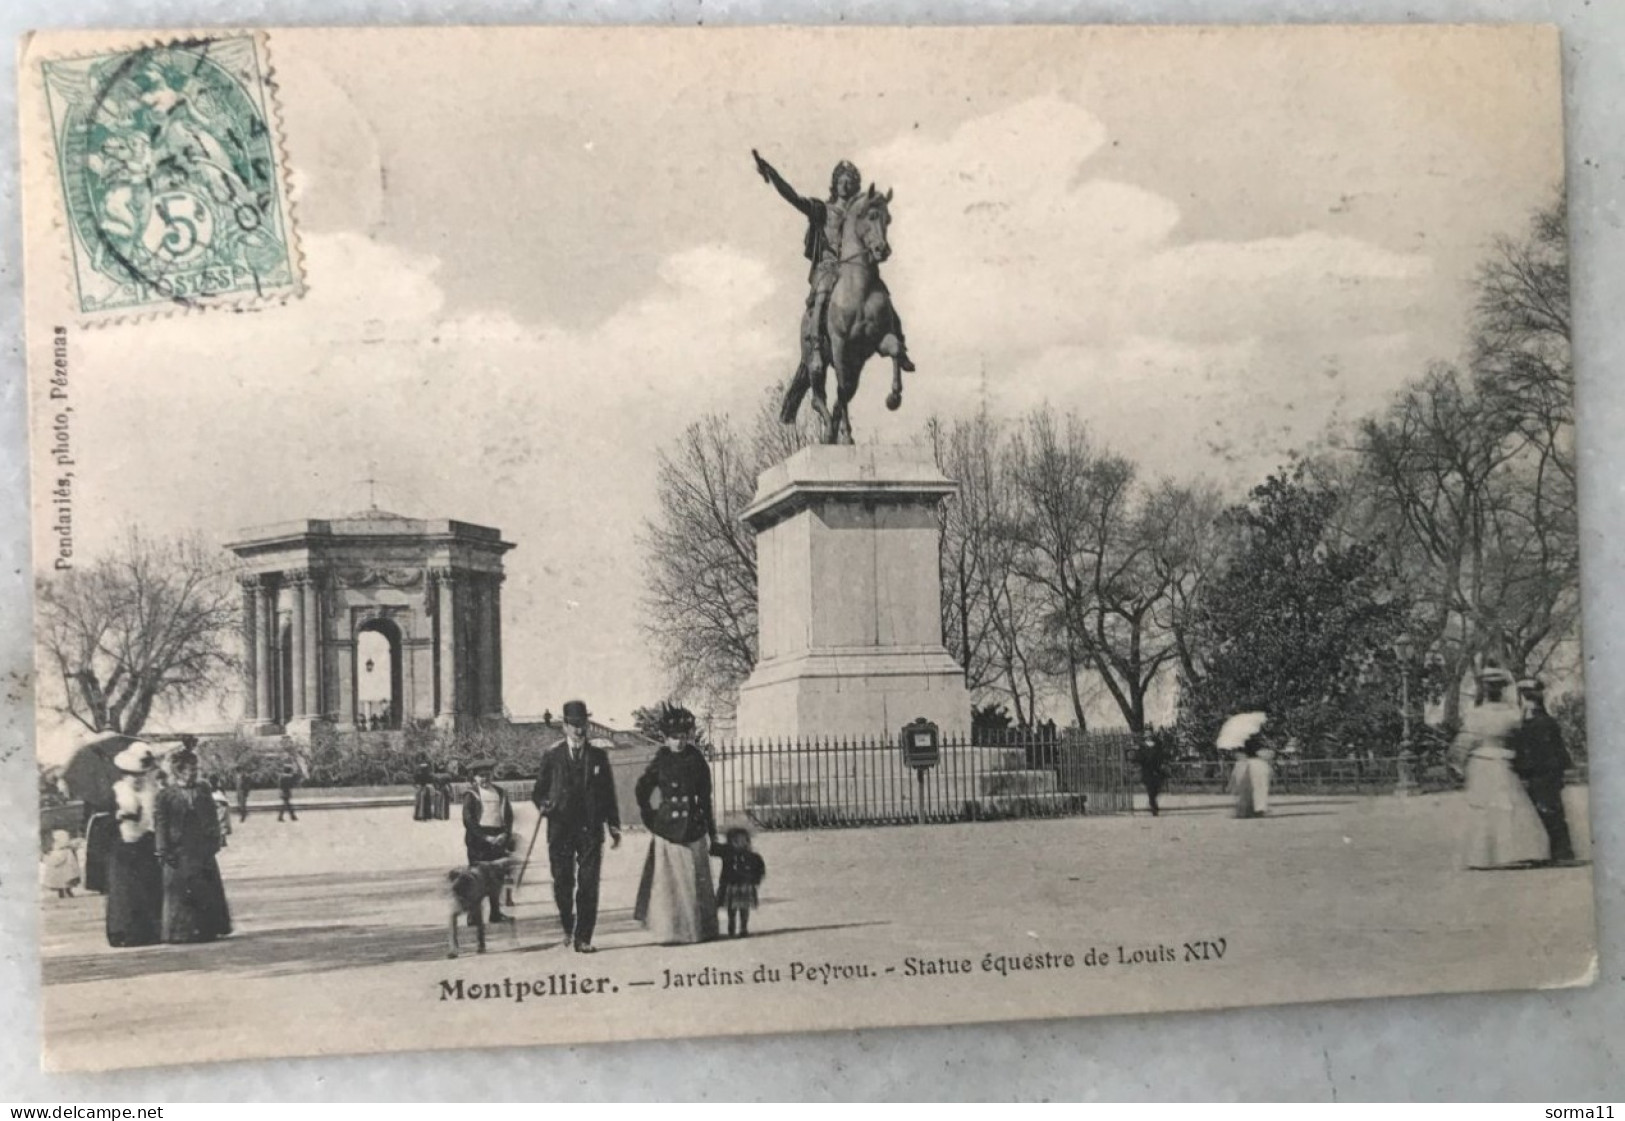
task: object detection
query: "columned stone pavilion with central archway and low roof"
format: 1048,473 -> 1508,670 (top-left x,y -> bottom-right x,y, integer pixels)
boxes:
226,509 -> 514,736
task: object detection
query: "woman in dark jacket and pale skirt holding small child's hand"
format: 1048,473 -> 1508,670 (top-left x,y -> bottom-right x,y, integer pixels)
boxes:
632,705 -> 717,946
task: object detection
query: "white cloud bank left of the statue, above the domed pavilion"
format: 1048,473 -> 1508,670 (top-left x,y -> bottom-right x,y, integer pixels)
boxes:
76,234 -> 780,715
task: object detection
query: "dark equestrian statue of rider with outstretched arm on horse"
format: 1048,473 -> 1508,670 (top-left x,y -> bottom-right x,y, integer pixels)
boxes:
751,148 -> 913,444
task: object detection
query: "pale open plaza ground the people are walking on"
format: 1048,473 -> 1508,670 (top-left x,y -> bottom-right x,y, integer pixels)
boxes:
41,783 -> 1594,1069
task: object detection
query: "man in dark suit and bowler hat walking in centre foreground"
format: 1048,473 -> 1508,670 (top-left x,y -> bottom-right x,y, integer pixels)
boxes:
531,700 -> 621,954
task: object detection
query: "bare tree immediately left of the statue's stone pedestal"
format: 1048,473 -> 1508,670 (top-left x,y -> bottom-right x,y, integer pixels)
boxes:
639,383 -> 808,703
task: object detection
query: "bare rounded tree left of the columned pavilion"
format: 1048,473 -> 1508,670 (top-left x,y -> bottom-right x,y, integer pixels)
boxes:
36,530 -> 241,736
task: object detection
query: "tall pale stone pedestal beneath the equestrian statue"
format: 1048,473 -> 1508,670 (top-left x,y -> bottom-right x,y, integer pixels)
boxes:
738,445 -> 970,739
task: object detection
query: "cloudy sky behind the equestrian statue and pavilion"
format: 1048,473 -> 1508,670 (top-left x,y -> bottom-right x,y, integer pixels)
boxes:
24,28 -> 1562,734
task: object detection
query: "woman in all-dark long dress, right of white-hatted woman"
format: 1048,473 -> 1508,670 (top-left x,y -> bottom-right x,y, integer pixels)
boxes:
153,747 -> 231,942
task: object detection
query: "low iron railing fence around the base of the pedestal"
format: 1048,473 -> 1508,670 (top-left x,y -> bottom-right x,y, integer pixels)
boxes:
712,733 -> 1134,830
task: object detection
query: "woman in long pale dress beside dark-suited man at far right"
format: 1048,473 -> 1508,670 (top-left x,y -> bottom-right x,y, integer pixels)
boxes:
1461,668 -> 1550,869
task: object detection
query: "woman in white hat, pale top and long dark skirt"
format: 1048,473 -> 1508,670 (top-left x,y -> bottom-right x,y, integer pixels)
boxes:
107,742 -> 163,947
